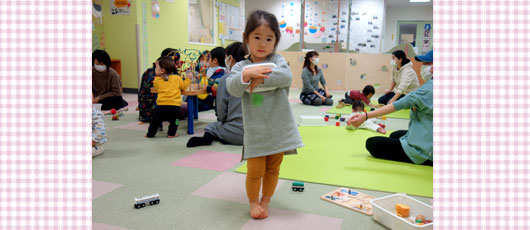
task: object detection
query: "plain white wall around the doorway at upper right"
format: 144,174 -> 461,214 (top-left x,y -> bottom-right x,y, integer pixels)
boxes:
381,6 -> 435,52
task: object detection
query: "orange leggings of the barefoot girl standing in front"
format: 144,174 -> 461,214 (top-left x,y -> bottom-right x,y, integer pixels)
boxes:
245,153 -> 283,201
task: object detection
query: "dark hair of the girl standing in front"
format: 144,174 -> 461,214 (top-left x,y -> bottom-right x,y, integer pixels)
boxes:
243,10 -> 281,52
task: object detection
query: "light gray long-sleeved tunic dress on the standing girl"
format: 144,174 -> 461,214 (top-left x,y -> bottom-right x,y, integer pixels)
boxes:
226,54 -> 304,159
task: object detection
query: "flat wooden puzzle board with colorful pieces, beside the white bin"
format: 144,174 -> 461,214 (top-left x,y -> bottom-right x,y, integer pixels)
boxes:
320,188 -> 375,215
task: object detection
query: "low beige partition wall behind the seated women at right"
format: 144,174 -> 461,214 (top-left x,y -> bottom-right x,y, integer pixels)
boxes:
278,51 -> 391,93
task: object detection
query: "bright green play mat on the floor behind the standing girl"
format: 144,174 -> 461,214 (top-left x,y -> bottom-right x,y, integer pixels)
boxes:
236,126 -> 433,197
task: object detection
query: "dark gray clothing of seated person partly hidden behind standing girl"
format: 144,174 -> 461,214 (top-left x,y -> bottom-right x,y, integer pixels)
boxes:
204,73 -> 243,145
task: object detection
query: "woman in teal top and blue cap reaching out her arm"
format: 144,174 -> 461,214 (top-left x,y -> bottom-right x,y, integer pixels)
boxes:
348,50 -> 433,166
